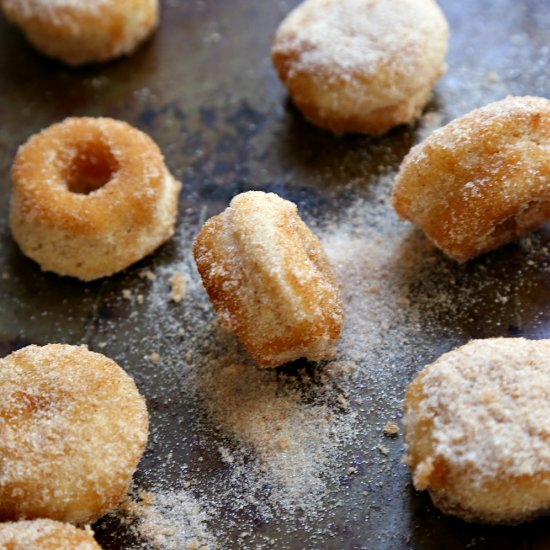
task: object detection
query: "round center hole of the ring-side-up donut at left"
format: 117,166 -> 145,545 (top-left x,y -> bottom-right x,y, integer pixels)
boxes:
66,142 -> 119,195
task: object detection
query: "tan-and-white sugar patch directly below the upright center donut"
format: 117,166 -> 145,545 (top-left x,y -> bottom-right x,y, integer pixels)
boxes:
197,357 -> 353,518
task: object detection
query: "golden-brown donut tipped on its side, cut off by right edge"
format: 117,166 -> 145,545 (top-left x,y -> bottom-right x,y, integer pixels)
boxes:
393,97 -> 550,262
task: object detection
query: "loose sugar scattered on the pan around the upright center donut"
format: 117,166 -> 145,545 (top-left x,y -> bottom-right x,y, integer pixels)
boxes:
96,166 -> 547,548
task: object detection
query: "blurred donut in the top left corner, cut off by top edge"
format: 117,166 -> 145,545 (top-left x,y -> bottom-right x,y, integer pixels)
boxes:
0,0 -> 159,65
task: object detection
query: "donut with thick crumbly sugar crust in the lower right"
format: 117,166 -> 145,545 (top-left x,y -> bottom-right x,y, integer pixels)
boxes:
403,338 -> 550,523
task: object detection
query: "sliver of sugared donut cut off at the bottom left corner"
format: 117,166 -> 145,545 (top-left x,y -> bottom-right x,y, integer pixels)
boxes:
0,519 -> 101,550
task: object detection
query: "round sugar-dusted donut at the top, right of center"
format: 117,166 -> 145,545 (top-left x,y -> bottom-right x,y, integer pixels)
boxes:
272,0 -> 449,134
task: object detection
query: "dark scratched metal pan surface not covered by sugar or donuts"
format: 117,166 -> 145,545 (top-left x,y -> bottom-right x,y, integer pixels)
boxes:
0,0 -> 550,549
